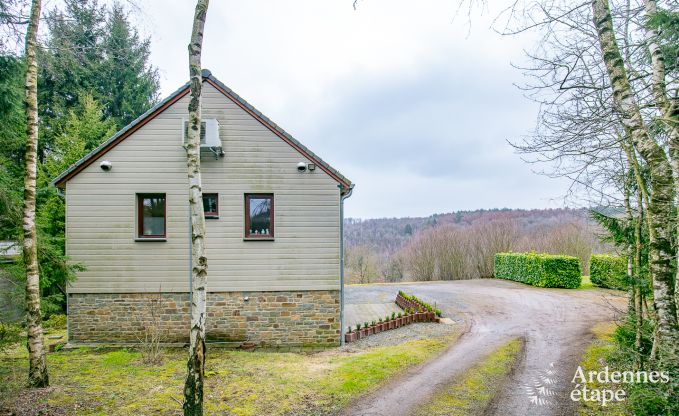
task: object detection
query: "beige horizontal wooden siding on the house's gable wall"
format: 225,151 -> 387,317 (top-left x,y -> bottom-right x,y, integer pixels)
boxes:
66,84 -> 339,292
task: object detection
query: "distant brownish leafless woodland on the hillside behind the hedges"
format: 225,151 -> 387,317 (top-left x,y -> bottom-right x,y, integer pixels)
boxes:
345,209 -> 610,283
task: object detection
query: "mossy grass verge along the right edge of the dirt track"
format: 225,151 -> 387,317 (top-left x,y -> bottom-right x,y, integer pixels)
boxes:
578,322 -> 630,416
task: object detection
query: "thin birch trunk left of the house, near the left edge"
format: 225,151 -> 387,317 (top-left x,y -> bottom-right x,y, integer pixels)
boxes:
22,0 -> 49,387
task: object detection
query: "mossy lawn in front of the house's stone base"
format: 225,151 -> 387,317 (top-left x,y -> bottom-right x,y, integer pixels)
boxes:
0,326 -> 456,415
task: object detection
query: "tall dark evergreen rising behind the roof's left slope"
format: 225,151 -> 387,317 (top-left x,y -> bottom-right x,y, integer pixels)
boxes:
39,0 -> 159,161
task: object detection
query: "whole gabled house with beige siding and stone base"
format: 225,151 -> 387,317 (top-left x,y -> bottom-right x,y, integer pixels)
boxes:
53,70 -> 353,346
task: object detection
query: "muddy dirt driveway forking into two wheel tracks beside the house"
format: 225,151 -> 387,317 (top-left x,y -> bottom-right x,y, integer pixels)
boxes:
342,280 -> 626,416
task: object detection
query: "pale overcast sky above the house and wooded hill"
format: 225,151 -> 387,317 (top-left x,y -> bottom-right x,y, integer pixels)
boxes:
135,0 -> 567,218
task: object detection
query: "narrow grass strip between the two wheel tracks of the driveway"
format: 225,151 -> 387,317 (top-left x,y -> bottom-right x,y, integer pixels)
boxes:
416,339 -> 522,416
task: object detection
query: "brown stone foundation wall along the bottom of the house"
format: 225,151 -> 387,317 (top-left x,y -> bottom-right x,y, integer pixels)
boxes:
68,290 -> 340,347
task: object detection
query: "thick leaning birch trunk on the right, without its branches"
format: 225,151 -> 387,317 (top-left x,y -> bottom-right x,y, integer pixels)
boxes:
592,0 -> 679,352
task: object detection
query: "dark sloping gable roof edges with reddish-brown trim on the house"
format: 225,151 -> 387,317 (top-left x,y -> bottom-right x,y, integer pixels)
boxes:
52,69 -> 352,193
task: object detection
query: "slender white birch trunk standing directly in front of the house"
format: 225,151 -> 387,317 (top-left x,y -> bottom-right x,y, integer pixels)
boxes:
184,0 -> 209,416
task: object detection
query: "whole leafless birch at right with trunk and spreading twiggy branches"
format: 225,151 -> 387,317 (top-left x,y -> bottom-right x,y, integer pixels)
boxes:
505,0 -> 679,356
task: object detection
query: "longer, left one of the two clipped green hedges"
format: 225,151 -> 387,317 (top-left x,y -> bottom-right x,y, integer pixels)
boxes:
495,253 -> 582,289
